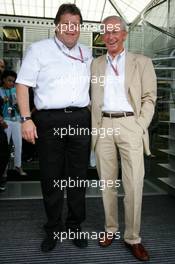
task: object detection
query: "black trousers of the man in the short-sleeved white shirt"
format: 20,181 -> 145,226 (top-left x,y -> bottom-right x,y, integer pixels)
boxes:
34,108 -> 90,233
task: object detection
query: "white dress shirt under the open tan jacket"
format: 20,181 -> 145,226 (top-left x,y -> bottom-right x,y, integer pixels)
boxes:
102,51 -> 133,112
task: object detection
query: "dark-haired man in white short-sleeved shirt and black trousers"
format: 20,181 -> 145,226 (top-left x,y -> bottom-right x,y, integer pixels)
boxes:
16,4 -> 92,252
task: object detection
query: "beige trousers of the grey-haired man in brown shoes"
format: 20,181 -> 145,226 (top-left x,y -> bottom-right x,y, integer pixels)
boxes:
95,116 -> 144,244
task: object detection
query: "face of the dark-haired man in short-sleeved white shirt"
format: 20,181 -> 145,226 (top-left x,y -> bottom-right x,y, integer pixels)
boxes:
56,13 -> 80,49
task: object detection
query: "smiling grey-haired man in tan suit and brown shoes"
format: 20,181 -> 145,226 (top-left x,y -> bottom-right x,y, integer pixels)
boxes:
91,16 -> 156,260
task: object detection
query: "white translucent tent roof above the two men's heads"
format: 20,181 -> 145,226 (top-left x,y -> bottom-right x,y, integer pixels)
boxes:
0,0 -> 156,24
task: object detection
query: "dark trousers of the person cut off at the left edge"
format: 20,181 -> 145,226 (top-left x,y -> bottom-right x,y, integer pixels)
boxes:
0,126 -> 9,180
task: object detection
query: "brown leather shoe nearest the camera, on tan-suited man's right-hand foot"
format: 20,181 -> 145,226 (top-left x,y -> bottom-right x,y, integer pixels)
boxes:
125,242 -> 149,261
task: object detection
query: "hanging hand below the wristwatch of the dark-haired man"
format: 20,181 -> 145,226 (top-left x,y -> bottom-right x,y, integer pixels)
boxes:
22,120 -> 38,144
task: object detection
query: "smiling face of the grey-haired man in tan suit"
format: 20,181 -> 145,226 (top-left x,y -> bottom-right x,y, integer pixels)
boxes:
102,18 -> 127,57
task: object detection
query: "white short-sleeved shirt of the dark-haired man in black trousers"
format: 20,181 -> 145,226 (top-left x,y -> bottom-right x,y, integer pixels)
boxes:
16,37 -> 92,110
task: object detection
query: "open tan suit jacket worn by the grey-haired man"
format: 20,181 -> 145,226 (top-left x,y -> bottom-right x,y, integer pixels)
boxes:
91,52 -> 157,155
